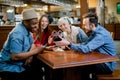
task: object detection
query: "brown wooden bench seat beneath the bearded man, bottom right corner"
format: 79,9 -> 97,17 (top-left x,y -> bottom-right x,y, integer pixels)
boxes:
97,70 -> 120,80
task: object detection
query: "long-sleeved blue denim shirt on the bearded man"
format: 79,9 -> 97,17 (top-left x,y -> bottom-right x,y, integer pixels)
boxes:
71,25 -> 116,71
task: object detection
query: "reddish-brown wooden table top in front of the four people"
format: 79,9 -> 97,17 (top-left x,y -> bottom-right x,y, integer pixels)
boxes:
37,50 -> 119,69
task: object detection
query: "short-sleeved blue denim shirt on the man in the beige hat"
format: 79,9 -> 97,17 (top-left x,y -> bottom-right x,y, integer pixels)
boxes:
0,23 -> 33,72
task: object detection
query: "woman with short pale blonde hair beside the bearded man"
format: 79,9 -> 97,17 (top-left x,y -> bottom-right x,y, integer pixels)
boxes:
58,17 -> 88,43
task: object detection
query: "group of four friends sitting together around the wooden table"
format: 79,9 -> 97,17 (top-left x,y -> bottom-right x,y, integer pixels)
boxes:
0,9 -> 116,80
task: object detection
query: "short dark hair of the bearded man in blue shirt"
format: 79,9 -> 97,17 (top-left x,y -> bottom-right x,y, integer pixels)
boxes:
83,13 -> 98,27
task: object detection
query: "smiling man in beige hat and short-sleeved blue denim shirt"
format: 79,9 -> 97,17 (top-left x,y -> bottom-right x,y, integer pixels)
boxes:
0,9 -> 43,80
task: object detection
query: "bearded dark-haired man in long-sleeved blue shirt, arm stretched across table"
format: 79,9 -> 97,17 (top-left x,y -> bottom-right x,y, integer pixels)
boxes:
55,13 -> 116,80
